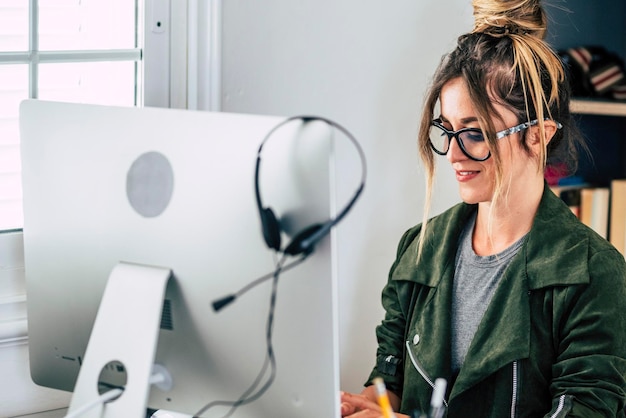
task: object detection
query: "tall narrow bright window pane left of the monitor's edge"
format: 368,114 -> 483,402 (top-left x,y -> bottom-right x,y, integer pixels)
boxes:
0,65 -> 28,230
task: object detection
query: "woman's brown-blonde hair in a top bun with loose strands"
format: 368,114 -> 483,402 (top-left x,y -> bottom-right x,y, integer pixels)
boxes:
418,0 -> 583,258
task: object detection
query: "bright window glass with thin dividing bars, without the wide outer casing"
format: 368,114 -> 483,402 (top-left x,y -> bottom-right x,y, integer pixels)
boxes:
0,0 -> 143,230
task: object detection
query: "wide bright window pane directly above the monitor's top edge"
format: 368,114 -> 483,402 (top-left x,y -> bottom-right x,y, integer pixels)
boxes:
39,61 -> 136,106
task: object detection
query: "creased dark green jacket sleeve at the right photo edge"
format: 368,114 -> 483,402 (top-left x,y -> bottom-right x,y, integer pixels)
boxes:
546,249 -> 626,417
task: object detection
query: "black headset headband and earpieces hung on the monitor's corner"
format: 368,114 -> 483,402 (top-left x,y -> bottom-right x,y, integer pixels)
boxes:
254,116 -> 367,256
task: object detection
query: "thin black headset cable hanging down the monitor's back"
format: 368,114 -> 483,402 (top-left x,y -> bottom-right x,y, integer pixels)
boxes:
193,256 -> 288,418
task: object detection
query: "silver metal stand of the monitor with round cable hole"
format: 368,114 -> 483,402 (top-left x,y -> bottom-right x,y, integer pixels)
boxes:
69,262 -> 172,418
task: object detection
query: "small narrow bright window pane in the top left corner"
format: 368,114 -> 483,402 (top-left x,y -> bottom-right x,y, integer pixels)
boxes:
0,0 -> 28,52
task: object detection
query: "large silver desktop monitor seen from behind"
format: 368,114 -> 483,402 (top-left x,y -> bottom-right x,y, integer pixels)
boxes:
20,100 -> 346,418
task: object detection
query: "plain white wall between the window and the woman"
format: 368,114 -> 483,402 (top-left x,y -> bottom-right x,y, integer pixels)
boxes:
221,0 -> 472,391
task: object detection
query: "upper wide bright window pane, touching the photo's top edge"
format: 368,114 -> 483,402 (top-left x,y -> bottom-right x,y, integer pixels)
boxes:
39,0 -> 136,51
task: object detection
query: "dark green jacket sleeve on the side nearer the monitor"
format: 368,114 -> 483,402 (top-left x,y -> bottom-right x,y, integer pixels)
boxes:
365,225 -> 421,396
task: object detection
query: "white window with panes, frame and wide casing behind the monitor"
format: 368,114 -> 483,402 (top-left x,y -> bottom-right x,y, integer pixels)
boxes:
0,0 -> 212,416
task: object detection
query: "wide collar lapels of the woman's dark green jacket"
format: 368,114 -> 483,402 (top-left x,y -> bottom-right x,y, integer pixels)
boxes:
392,184 -> 589,290
